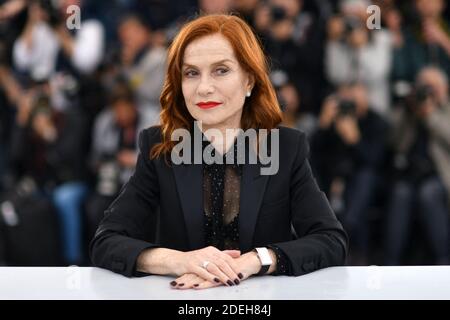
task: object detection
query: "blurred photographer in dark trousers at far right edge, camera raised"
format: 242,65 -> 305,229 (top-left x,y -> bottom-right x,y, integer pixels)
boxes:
385,67 -> 450,265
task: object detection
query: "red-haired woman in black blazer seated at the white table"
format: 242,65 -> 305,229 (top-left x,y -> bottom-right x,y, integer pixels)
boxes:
90,15 -> 347,289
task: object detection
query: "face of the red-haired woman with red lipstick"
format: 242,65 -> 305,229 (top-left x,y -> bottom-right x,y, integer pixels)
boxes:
182,34 -> 252,129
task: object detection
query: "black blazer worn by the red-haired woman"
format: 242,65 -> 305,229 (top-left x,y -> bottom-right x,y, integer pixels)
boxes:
90,127 -> 348,276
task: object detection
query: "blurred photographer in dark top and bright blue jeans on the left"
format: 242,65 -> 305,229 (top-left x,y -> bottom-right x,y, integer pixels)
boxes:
11,83 -> 87,264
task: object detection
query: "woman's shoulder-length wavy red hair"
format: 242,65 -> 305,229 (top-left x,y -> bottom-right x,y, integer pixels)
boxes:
150,14 -> 282,158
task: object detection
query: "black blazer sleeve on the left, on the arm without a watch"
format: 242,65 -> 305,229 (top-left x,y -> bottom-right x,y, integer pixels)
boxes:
89,130 -> 159,277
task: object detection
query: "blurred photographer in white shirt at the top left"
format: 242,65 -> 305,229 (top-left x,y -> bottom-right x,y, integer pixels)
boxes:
13,0 -> 104,80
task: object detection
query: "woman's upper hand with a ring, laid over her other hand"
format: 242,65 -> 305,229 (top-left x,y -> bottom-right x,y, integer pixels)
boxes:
172,246 -> 243,286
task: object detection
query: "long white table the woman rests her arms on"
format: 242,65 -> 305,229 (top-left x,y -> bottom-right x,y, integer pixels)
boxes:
0,266 -> 450,300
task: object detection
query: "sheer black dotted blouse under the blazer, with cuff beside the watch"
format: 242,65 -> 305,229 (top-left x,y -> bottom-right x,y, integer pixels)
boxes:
203,136 -> 290,275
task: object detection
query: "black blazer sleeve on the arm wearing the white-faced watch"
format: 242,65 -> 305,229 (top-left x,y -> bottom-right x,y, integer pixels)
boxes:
273,134 -> 348,276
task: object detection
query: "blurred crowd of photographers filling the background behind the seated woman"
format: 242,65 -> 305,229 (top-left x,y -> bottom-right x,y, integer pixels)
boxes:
0,0 -> 450,266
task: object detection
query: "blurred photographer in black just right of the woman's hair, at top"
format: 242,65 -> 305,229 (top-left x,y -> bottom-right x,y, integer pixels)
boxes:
254,0 -> 325,114
